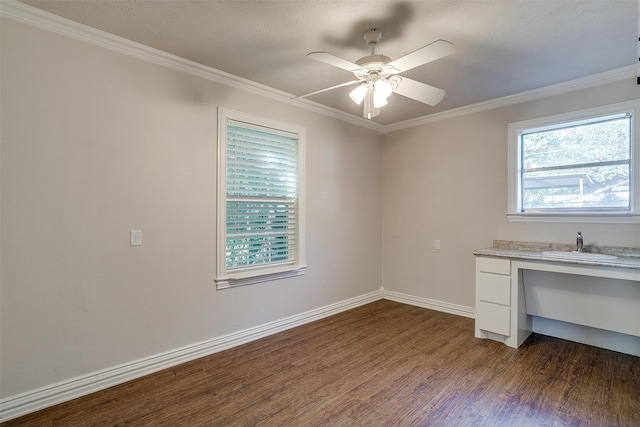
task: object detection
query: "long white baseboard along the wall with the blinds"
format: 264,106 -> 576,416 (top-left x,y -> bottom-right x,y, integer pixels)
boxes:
0,290 -> 382,422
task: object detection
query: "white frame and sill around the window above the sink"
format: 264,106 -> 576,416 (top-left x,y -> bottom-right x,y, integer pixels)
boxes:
507,100 -> 640,223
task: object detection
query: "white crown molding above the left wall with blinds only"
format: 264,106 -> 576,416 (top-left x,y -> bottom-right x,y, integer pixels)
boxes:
0,0 -> 384,133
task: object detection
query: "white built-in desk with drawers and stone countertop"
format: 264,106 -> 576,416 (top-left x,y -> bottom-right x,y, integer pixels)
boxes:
474,241 -> 640,356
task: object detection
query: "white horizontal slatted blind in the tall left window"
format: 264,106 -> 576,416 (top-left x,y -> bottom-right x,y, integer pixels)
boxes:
226,121 -> 298,271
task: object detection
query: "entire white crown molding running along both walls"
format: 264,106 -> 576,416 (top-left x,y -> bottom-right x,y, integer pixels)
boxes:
0,0 -> 640,134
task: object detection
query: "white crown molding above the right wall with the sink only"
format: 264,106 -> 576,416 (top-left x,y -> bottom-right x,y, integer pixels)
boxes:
383,65 -> 640,133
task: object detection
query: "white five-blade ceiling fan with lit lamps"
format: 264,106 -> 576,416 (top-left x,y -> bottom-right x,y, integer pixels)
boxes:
296,29 -> 456,119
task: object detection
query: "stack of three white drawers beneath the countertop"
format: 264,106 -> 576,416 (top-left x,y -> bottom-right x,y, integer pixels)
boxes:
475,257 -> 512,343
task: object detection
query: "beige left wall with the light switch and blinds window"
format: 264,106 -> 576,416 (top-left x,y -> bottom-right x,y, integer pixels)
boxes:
0,19 -> 382,398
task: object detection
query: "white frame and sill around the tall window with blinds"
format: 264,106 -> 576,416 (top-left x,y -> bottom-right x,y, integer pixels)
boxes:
215,107 -> 307,289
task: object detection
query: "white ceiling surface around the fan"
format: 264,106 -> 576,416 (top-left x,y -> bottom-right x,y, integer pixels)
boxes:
16,0 -> 639,125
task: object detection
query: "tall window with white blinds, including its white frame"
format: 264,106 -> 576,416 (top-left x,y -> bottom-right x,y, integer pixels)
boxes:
216,108 -> 306,289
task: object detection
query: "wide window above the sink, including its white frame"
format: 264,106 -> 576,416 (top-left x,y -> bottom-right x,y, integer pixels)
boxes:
508,101 -> 640,222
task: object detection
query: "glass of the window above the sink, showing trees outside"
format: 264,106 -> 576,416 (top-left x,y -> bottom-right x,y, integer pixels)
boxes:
520,115 -> 631,212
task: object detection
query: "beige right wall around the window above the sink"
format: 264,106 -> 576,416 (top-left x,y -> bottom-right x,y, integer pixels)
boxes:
383,79 -> 640,307
